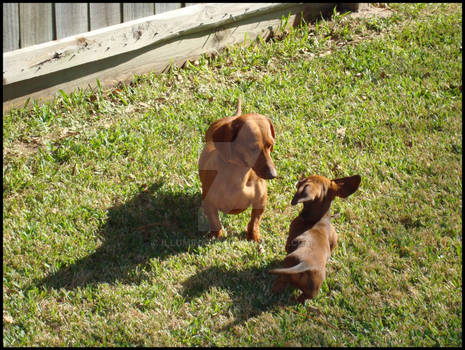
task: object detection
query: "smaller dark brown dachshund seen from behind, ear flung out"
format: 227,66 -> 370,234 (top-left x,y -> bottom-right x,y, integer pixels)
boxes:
270,175 -> 361,303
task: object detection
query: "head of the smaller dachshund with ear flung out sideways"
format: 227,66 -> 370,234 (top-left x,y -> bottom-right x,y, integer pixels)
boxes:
291,175 -> 362,208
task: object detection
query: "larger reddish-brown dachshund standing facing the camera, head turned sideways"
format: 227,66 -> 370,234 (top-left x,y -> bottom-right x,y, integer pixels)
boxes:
199,100 -> 277,242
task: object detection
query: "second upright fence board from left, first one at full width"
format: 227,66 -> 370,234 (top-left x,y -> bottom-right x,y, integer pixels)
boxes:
19,2 -> 53,47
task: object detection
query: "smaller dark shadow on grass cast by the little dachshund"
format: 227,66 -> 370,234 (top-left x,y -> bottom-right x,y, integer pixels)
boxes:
182,260 -> 297,331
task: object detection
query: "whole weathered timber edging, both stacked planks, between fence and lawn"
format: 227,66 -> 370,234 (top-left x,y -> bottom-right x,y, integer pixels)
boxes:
3,3 -> 344,111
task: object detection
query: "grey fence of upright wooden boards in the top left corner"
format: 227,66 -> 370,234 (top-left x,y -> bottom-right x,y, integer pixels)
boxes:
3,3 -> 197,52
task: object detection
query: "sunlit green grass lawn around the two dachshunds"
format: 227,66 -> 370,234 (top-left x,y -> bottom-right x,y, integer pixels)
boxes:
3,4 -> 462,346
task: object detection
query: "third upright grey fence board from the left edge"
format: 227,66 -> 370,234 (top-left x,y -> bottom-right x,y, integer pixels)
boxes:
55,2 -> 88,39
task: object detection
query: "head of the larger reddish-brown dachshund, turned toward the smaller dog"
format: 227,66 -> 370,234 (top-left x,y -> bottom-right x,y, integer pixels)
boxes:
212,114 -> 277,179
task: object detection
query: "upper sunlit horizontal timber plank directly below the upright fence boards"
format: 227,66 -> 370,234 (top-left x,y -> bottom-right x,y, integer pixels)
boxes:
3,3 -> 296,85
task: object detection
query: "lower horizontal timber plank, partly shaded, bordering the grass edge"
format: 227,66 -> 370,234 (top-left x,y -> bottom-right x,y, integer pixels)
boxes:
3,4 -> 329,111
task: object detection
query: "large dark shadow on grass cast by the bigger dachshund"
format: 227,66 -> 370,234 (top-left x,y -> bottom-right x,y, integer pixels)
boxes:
36,182 -> 211,289
